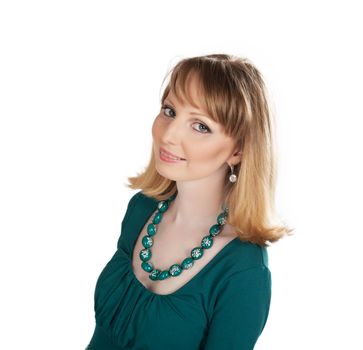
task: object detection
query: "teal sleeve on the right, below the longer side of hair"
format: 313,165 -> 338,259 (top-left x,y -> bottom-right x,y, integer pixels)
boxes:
204,265 -> 271,350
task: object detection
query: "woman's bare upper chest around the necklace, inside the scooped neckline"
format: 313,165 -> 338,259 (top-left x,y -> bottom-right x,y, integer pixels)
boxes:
132,213 -> 236,295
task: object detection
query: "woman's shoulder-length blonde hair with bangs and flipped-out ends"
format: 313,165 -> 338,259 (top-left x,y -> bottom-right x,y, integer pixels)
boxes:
126,54 -> 292,246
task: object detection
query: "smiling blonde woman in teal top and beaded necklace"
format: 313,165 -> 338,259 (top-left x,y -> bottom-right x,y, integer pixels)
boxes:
87,54 -> 291,350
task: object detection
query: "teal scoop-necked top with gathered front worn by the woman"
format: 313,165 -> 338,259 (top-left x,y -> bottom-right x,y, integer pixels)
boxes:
86,191 -> 271,350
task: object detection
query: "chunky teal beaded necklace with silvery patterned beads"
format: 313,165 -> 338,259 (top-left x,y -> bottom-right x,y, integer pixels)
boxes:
139,193 -> 228,281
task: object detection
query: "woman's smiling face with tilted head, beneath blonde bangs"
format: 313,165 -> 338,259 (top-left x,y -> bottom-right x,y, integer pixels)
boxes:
152,74 -> 239,181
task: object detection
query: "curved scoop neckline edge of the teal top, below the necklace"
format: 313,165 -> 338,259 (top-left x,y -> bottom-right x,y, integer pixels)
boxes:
128,198 -> 239,298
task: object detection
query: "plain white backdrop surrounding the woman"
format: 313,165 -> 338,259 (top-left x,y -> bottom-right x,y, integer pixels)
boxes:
0,0 -> 363,350
